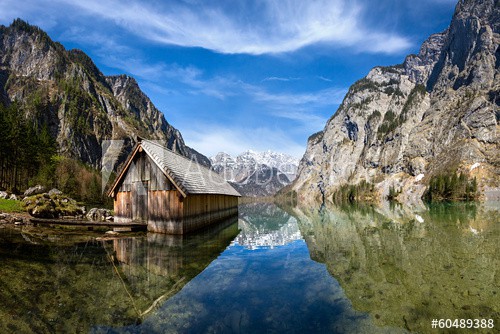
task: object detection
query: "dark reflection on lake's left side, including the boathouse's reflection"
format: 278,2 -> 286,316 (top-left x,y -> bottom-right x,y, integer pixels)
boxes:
0,218 -> 238,333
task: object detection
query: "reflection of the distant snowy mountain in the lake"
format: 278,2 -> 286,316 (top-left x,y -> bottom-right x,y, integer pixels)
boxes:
233,203 -> 302,249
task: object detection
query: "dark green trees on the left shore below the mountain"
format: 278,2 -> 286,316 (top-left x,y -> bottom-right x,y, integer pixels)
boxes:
0,103 -> 109,204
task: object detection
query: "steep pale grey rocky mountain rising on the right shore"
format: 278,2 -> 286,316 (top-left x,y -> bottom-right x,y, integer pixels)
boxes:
291,0 -> 500,201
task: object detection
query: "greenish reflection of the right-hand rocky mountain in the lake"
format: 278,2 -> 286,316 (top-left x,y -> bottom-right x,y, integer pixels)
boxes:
293,200 -> 500,332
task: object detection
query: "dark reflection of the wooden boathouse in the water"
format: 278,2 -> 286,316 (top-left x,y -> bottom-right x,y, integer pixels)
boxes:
107,216 -> 239,317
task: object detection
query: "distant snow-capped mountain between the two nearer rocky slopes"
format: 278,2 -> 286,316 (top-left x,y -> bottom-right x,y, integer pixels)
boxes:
210,150 -> 299,196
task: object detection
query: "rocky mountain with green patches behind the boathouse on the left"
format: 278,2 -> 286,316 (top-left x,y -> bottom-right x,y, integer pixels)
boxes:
0,19 -> 210,167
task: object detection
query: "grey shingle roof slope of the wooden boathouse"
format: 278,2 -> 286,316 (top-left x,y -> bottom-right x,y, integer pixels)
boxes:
140,139 -> 241,196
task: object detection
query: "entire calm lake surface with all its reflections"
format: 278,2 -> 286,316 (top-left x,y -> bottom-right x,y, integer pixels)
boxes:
0,203 -> 500,333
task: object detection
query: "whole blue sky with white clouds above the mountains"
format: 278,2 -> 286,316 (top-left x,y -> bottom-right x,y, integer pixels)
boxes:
0,0 -> 456,157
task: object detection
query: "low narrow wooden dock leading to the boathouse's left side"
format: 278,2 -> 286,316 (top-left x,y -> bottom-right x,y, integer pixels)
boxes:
30,218 -> 148,232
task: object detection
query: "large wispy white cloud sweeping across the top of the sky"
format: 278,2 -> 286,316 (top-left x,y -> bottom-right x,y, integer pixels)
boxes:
54,0 -> 410,55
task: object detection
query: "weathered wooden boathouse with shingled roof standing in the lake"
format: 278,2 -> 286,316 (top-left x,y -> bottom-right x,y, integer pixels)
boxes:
108,139 -> 241,234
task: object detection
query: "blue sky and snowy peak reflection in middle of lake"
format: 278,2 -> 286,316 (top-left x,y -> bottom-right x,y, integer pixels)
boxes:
117,203 -> 398,334
